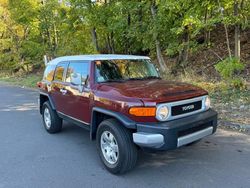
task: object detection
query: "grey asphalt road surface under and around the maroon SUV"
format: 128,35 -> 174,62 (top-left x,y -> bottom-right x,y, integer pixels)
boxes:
0,84 -> 250,188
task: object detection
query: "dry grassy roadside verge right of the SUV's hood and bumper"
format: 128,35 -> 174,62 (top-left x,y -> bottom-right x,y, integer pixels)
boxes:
175,72 -> 250,127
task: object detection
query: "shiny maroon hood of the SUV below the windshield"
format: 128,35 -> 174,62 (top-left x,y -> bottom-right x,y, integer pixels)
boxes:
98,79 -> 207,103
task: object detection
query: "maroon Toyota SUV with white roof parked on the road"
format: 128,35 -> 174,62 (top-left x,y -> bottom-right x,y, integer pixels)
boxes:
38,55 -> 217,173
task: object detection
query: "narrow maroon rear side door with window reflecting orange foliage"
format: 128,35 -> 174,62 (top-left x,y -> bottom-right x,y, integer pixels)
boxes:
51,62 -> 68,113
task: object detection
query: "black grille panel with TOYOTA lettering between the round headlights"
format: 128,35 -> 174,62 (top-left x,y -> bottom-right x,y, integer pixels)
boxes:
171,101 -> 202,116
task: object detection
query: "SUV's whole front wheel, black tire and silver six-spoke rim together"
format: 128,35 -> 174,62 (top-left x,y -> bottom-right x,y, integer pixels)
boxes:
97,119 -> 137,174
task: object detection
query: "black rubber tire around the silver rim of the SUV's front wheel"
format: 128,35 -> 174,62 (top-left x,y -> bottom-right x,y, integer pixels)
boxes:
96,119 -> 138,174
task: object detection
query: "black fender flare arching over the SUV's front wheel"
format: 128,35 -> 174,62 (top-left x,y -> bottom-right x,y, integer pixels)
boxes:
90,107 -> 136,140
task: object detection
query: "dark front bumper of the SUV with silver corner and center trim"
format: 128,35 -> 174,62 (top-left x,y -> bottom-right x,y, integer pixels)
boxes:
133,109 -> 217,150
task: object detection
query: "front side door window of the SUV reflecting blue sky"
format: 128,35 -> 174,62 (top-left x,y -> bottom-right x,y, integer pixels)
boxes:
66,62 -> 89,85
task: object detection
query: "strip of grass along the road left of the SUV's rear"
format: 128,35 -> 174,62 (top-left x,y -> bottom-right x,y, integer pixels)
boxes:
0,73 -> 42,88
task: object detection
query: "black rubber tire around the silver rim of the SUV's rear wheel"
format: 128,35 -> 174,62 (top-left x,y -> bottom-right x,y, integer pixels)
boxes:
42,101 -> 62,134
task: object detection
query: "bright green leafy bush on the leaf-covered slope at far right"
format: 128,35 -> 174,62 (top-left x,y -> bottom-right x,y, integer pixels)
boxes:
215,58 -> 244,80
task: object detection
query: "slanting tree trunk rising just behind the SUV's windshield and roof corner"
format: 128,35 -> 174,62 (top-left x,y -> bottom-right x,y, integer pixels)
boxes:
151,0 -> 166,71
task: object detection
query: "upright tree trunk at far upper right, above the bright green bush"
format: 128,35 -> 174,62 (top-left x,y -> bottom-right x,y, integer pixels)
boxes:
234,0 -> 240,60
